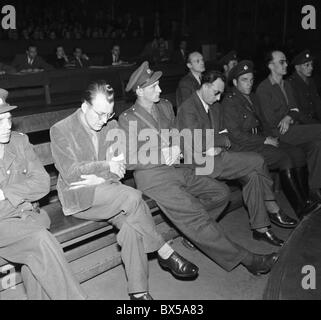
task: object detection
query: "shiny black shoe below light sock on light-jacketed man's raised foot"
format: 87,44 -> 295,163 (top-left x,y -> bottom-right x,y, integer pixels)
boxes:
158,252 -> 198,278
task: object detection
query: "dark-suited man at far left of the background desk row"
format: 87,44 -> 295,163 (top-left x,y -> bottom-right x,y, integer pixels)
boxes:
12,45 -> 53,72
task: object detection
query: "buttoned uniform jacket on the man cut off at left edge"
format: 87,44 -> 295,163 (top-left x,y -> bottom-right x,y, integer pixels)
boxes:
0,131 -> 50,221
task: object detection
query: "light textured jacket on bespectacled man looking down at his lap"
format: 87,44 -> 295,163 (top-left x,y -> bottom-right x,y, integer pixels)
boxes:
50,109 -> 119,215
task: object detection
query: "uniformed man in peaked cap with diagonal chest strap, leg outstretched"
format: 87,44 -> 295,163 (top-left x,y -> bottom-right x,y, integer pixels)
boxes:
119,62 -> 277,274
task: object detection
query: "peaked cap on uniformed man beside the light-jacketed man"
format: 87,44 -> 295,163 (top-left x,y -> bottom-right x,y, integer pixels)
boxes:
126,61 -> 163,92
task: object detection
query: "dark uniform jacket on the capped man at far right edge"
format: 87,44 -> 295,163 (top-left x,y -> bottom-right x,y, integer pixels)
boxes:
289,72 -> 321,124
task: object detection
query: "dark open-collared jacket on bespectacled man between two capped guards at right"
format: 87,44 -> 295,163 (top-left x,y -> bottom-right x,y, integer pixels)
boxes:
256,77 -> 301,136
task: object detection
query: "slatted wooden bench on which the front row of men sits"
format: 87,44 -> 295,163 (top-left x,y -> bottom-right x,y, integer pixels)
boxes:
0,108 -> 242,298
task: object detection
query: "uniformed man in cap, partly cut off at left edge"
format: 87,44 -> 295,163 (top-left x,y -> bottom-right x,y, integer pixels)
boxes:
0,89 -> 86,300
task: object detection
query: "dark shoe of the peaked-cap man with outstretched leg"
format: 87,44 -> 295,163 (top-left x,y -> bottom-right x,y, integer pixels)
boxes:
242,252 -> 279,276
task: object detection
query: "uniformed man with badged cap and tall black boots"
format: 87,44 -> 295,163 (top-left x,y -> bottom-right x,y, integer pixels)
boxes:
222,60 -> 312,217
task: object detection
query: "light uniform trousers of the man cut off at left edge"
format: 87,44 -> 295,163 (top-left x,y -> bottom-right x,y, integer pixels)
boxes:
0,222 -> 86,300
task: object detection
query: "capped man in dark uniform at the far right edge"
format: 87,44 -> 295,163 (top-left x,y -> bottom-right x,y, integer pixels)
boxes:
289,50 -> 321,124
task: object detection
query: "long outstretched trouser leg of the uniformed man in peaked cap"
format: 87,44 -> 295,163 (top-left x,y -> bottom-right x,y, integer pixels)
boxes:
138,171 -> 248,271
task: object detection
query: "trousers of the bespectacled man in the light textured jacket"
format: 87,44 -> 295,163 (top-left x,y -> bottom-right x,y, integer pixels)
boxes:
76,185 -> 165,293
